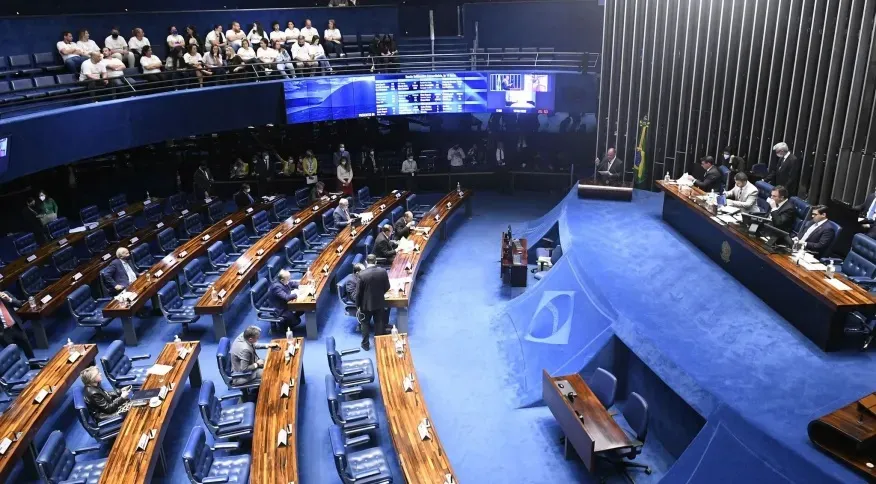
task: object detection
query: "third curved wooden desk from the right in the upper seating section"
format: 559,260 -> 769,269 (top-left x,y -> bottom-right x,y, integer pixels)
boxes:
195,196 -> 340,337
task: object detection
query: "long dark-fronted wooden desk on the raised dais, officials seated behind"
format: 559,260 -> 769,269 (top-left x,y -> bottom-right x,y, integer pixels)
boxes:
657,180 -> 876,351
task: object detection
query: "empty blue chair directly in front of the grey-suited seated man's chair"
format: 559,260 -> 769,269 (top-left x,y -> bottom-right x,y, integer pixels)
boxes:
198,380 -> 255,440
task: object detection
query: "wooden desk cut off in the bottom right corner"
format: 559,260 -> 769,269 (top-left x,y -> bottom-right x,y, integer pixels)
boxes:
808,393 -> 876,482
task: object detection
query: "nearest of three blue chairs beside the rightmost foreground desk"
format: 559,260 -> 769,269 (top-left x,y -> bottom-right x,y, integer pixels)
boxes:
329,425 -> 392,484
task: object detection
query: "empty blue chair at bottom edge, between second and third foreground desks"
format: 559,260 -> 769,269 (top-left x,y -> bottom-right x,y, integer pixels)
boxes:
183,427 -> 252,484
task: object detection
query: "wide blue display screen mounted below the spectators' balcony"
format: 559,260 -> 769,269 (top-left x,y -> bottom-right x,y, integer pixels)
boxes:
283,72 -> 554,123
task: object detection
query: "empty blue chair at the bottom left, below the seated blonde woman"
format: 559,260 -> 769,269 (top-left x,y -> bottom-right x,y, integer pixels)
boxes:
36,430 -> 106,484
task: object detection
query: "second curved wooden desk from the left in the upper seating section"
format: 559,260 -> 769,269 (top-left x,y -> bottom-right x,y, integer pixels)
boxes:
17,208 -> 195,349
